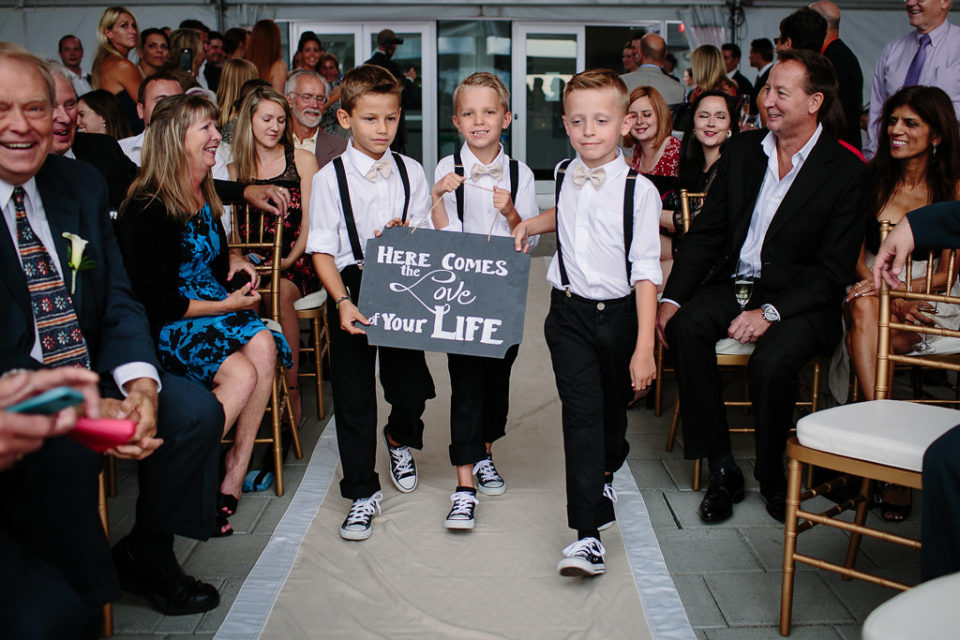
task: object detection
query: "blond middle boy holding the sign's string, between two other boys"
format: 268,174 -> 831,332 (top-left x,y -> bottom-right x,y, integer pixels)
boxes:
430,72 -> 539,530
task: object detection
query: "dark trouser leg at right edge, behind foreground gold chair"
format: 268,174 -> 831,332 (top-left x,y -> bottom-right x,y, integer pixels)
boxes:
920,425 -> 960,580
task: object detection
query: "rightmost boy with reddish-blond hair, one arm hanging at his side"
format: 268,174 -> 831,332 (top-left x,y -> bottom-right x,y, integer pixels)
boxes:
513,69 -> 661,576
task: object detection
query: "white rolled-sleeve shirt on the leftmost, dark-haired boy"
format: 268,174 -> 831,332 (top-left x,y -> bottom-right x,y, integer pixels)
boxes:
306,139 -> 432,270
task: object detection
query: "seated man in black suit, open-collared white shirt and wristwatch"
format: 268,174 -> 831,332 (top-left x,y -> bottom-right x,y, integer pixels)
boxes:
657,51 -> 864,522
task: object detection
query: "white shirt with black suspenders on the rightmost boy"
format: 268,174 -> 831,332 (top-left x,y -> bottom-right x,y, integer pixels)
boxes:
547,149 -> 663,300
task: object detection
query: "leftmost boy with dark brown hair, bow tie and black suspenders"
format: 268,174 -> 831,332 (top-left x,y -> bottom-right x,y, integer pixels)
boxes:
307,65 -> 436,540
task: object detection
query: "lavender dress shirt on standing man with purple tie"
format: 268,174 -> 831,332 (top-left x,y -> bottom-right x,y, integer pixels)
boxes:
863,20 -> 960,160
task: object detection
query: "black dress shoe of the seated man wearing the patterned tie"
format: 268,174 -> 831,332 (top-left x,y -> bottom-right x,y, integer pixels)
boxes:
113,538 -> 220,616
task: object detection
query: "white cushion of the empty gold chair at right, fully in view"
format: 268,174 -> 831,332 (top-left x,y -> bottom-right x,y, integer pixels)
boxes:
797,400 -> 960,471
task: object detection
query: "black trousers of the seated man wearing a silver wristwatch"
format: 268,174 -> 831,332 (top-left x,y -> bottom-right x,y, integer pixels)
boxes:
666,280 -> 824,491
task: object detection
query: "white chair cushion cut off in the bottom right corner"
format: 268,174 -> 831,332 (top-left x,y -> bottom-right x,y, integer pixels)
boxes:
862,573 -> 960,640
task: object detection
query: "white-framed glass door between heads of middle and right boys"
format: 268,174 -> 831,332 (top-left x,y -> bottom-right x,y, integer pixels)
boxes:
511,23 -> 585,180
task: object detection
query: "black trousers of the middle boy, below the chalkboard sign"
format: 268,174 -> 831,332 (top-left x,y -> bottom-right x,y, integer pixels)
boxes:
447,344 -> 520,465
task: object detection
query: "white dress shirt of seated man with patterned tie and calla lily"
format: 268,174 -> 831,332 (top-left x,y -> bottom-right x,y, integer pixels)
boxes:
0,178 -> 160,395
